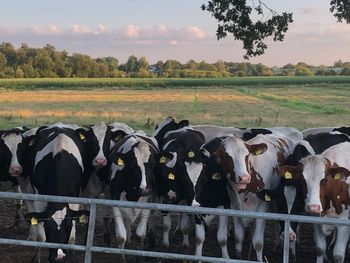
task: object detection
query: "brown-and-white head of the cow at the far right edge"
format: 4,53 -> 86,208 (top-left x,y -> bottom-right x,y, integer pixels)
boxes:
279,158 -> 350,215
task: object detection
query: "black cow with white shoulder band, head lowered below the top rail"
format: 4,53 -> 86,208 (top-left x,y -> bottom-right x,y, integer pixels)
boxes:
26,124 -> 89,262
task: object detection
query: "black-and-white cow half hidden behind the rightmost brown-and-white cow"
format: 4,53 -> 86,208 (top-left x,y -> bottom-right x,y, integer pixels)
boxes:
258,132 -> 350,257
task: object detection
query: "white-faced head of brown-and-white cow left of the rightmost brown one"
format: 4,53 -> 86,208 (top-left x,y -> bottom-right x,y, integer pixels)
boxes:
215,136 -> 267,190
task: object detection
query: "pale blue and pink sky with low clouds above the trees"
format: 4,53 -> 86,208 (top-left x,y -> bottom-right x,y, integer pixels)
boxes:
0,0 -> 350,66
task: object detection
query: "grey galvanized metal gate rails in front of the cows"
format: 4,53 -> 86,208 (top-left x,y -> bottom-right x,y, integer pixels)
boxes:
0,192 -> 350,263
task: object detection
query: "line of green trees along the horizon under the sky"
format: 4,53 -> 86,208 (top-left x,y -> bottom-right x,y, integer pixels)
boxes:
0,42 -> 350,78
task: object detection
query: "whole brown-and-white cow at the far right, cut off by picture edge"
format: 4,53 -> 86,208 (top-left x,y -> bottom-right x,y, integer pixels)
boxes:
279,141 -> 350,263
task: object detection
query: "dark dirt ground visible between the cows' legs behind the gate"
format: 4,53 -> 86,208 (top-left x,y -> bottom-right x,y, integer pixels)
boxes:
0,197 -> 350,263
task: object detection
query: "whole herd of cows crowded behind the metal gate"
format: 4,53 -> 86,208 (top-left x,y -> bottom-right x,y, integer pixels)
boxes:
0,117 -> 350,263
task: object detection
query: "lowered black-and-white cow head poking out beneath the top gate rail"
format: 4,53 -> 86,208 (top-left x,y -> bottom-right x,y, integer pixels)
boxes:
25,205 -> 89,262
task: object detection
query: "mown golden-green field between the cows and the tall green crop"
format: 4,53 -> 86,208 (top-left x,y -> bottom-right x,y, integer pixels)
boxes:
0,84 -> 350,132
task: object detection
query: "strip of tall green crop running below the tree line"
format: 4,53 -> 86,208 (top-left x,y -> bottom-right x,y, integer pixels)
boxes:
0,76 -> 350,89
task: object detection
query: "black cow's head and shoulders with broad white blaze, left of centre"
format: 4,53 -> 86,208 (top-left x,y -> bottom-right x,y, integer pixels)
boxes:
109,135 -> 156,201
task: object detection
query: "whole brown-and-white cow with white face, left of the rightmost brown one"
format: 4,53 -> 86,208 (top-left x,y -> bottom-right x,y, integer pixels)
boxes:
215,133 -> 301,261
